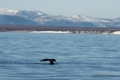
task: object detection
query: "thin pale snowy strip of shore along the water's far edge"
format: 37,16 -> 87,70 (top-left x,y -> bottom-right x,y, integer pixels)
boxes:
2,30 -> 120,35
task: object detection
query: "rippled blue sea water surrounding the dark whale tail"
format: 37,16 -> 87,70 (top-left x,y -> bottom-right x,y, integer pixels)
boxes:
0,32 -> 120,80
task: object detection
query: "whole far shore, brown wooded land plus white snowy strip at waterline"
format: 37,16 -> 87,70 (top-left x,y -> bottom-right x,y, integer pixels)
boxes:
0,25 -> 120,34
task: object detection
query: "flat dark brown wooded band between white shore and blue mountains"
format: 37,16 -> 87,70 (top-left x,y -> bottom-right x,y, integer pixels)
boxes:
0,25 -> 120,32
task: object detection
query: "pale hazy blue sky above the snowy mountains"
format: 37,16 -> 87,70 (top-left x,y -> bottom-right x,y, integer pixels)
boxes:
0,0 -> 120,18
